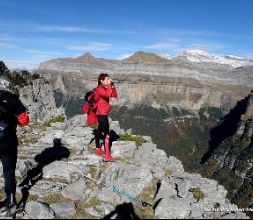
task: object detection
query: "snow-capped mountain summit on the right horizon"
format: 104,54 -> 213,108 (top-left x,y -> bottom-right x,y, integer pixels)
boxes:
177,50 -> 253,68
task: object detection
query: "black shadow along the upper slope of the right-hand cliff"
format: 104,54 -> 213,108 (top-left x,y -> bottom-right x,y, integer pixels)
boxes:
201,96 -> 250,164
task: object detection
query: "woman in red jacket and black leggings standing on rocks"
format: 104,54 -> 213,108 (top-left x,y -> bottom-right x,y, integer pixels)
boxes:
94,73 -> 117,161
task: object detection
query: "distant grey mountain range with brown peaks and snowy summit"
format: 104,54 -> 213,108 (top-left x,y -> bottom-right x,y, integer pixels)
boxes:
39,50 -> 253,86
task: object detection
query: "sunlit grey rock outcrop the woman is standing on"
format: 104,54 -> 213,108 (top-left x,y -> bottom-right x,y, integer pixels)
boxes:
14,116 -> 250,219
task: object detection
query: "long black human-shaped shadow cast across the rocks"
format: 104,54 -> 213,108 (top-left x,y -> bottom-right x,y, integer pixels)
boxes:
17,138 -> 70,210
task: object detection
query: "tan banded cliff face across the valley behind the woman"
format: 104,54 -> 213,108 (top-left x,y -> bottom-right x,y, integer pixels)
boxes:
36,72 -> 249,115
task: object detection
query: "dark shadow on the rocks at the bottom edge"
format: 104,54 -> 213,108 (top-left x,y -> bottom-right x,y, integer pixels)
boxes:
103,203 -> 141,219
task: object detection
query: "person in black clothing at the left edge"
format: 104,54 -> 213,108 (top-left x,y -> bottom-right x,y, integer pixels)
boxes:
0,87 -> 29,213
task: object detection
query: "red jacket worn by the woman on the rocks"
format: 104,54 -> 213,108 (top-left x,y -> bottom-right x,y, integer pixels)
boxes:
95,84 -> 118,115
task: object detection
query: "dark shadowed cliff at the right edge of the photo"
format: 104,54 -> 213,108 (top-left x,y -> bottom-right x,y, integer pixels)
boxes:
204,92 -> 253,216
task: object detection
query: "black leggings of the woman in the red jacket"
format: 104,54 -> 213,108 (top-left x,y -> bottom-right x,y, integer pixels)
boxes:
95,115 -> 110,148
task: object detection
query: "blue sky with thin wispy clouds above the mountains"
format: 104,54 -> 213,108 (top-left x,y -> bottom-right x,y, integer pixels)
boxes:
0,0 -> 253,69
